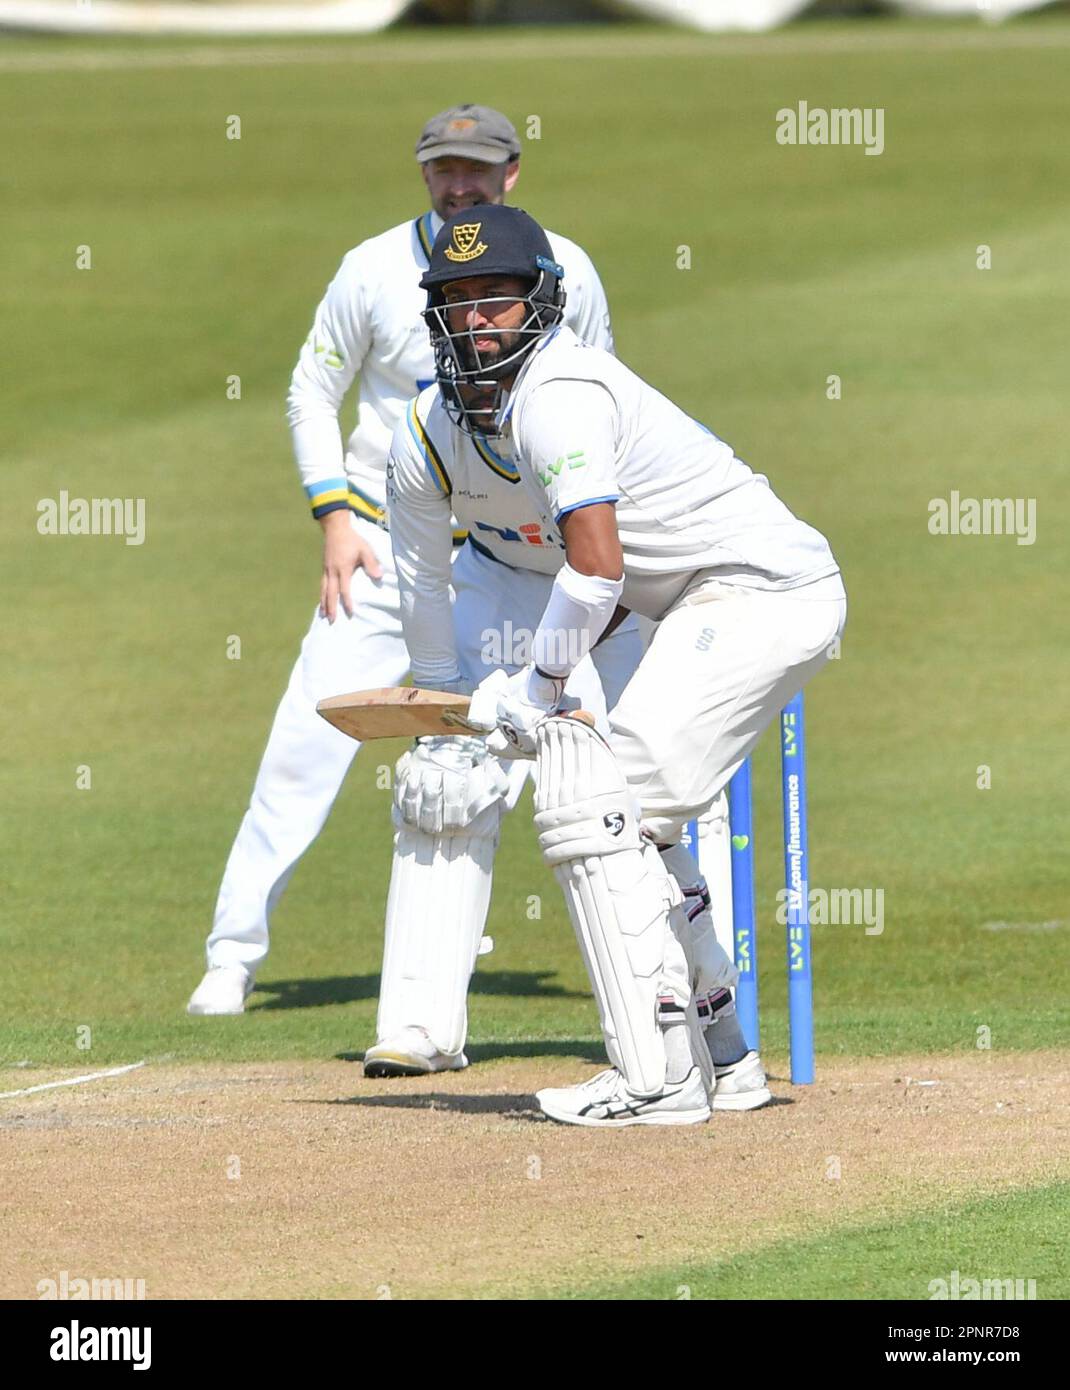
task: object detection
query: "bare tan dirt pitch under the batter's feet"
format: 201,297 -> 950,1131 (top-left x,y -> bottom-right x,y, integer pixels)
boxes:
0,1052 -> 1070,1298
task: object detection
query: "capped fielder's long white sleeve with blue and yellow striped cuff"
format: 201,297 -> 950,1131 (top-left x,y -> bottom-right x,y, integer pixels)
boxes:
286,246 -> 372,517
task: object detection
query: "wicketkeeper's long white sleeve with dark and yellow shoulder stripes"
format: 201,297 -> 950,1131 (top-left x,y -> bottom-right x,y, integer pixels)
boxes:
386,400 -> 460,685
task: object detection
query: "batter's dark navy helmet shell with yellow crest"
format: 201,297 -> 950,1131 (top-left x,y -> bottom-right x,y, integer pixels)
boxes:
420,203 -> 564,289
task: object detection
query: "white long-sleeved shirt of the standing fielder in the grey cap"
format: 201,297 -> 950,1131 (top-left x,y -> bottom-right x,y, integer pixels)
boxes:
286,211 -> 613,524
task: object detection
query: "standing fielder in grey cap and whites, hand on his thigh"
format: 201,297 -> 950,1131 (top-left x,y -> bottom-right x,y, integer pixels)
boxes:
188,106 -> 616,1070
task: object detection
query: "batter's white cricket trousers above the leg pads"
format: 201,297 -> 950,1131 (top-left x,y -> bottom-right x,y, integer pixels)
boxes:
610,574 -> 846,844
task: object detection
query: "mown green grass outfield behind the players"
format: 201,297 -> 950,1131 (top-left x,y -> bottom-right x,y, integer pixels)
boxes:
0,17 -> 1070,1069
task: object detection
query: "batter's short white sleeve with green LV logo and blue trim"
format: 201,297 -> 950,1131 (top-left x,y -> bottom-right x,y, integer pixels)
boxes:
516,379 -> 620,523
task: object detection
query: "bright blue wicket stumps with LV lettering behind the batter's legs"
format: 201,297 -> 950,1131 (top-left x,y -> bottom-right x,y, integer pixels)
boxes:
688,692 -> 814,1086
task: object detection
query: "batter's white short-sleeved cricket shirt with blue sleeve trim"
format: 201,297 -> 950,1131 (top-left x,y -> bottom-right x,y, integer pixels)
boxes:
499,328 -> 838,620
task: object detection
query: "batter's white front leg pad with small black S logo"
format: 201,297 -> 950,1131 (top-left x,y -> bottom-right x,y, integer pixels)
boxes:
535,719 -> 678,1095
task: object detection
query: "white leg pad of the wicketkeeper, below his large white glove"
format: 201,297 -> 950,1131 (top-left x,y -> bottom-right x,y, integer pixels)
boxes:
377,801 -> 502,1054
